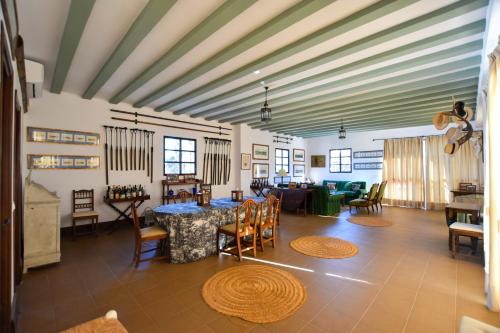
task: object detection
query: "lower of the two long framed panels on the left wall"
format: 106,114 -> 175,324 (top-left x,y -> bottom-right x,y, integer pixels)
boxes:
28,154 -> 100,170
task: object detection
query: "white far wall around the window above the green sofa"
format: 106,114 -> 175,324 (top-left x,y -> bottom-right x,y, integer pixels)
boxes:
305,125 -> 443,188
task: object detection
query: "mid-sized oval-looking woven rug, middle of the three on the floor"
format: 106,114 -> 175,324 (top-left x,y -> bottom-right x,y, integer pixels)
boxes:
290,236 -> 358,259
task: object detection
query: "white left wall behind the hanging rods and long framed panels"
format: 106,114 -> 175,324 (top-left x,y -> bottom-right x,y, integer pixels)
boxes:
23,91 -> 240,226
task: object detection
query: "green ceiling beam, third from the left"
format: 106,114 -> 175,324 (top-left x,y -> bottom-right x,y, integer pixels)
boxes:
110,0 -> 256,104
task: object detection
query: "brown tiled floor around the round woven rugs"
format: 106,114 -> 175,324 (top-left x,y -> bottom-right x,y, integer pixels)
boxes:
19,208 -> 500,333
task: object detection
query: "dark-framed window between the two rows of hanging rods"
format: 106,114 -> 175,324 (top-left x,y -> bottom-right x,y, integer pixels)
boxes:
163,136 -> 196,175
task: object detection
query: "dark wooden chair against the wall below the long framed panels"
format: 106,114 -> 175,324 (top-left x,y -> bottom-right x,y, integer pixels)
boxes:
71,189 -> 99,238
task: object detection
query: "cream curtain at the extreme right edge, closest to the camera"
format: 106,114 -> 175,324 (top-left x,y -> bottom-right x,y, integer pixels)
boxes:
484,47 -> 500,311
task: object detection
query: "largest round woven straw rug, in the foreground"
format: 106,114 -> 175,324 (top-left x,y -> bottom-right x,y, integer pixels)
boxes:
202,265 -> 306,323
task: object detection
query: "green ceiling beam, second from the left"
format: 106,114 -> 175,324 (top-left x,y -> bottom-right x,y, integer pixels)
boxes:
82,0 -> 177,99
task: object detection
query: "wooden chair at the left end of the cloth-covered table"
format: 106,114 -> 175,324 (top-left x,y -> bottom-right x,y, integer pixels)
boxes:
130,204 -> 168,267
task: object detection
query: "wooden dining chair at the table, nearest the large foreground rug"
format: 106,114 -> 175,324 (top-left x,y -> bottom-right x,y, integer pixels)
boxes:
217,199 -> 262,261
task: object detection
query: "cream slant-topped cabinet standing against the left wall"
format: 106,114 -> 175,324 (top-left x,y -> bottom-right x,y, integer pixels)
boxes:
24,177 -> 61,271
